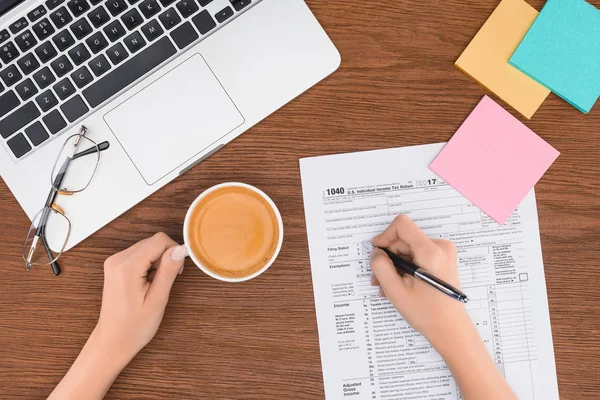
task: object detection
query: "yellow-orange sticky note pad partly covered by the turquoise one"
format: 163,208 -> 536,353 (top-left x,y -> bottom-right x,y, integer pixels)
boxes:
454,0 -> 550,118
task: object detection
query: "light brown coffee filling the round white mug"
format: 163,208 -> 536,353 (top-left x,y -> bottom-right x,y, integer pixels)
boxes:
187,185 -> 282,279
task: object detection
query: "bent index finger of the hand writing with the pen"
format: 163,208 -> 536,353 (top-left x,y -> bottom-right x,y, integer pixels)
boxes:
371,215 -> 439,264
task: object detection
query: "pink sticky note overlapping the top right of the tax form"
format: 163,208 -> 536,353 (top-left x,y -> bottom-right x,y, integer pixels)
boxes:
429,96 -> 560,224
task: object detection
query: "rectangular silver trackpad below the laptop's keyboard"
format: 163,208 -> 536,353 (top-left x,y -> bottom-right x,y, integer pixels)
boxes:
104,54 -> 244,185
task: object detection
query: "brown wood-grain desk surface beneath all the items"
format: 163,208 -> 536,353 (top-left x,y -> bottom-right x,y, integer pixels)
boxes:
0,0 -> 600,400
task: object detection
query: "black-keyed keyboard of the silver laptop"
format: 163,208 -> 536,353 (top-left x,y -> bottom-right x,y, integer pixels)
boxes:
0,0 -> 256,159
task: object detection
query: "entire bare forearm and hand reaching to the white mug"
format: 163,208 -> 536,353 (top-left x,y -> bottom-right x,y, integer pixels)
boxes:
48,233 -> 187,400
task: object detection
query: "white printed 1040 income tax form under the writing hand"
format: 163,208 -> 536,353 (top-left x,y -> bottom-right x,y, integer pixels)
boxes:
300,143 -> 558,400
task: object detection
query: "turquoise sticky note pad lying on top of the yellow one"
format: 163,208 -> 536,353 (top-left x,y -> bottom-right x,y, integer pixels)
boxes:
509,0 -> 600,113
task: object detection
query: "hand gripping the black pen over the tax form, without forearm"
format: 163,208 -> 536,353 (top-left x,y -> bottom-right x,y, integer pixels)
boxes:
371,215 -> 471,346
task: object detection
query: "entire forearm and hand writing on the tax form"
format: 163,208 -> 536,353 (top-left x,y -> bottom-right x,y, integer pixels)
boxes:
371,215 -> 516,400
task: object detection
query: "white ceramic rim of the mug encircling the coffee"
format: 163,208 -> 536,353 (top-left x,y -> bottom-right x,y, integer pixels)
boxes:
183,182 -> 283,282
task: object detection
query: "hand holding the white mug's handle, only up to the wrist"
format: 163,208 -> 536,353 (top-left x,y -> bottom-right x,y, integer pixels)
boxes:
95,233 -> 187,359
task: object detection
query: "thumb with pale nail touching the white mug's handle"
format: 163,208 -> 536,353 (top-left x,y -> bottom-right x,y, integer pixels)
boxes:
146,246 -> 187,307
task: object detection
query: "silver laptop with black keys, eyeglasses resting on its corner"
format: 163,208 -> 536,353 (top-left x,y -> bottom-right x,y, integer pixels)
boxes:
0,0 -> 340,249
